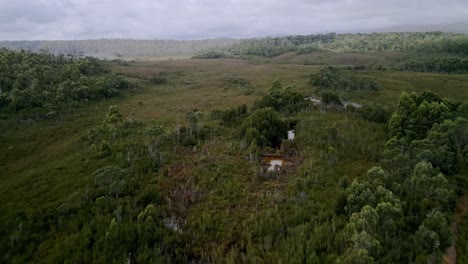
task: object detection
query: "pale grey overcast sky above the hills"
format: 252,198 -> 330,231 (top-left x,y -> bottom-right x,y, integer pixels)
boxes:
0,0 -> 468,40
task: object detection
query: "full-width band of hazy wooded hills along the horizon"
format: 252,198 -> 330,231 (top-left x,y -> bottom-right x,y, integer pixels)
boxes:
0,32 -> 468,59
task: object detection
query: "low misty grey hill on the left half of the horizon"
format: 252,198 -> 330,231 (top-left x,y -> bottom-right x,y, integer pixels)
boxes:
0,39 -> 239,59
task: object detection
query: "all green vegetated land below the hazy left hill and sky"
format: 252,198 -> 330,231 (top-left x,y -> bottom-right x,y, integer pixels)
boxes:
0,32 -> 468,264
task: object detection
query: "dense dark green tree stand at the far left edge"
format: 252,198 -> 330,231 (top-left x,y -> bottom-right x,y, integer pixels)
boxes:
0,49 -> 131,116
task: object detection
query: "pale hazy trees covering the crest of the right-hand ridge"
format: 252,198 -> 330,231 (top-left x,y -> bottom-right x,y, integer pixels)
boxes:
195,32 -> 468,58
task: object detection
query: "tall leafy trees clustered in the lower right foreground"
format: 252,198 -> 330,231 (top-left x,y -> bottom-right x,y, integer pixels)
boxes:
339,92 -> 468,263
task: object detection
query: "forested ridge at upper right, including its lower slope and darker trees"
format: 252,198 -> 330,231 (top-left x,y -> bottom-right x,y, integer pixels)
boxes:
194,32 -> 468,73
